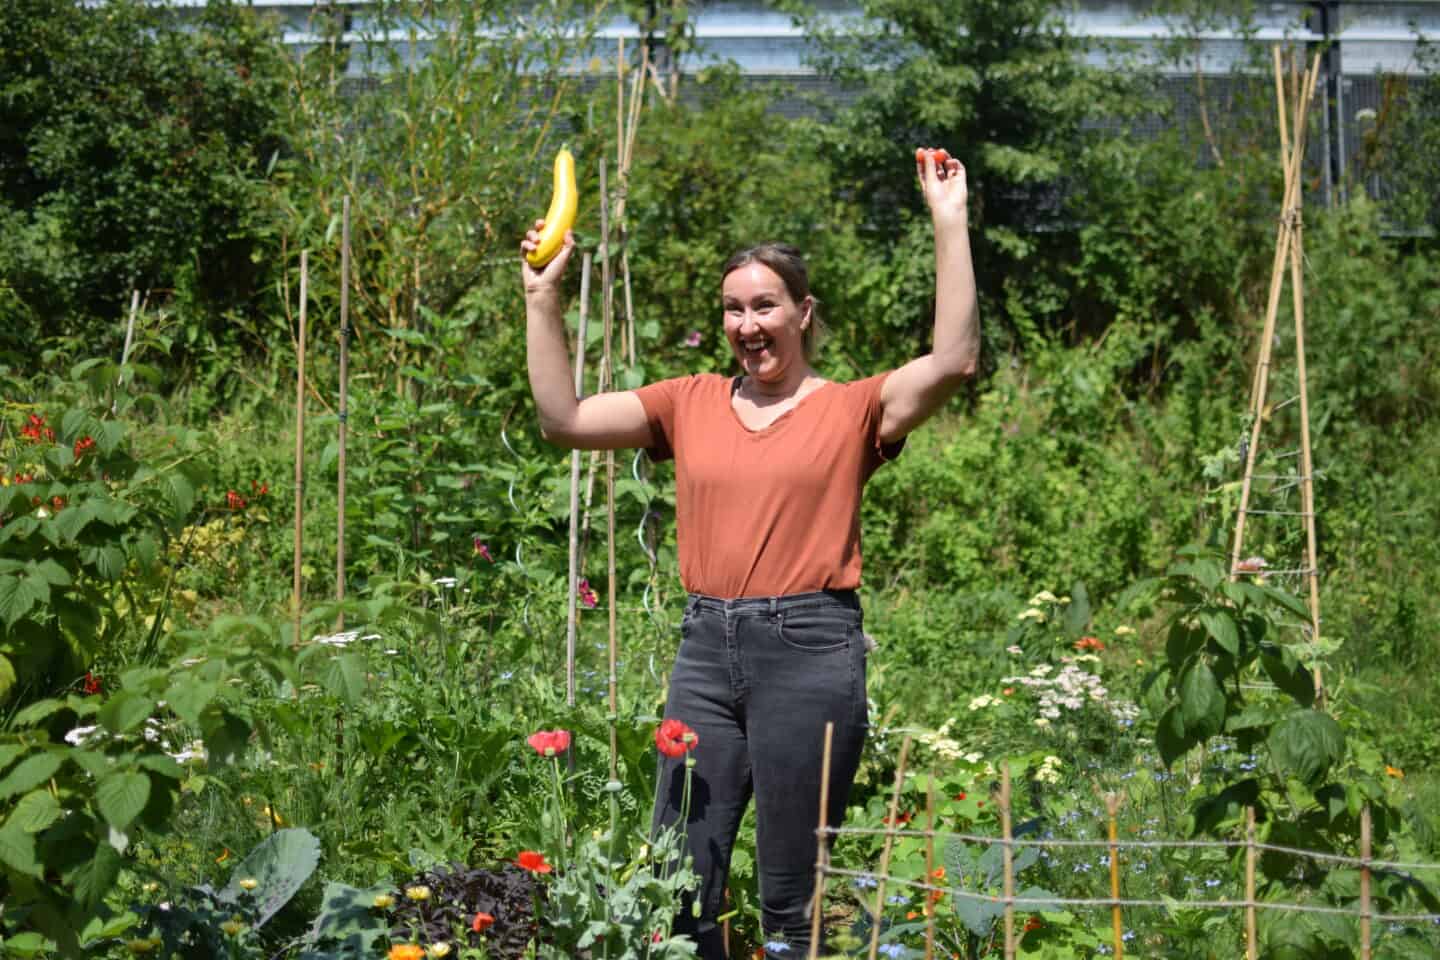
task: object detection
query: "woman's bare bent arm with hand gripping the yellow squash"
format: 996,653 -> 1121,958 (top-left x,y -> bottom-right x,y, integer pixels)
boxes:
520,220 -> 651,450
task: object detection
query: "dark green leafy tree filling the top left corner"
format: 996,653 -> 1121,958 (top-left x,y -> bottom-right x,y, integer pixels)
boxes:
0,0 -> 284,345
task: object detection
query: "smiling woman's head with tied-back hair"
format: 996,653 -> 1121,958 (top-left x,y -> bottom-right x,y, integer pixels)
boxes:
720,263 -> 811,383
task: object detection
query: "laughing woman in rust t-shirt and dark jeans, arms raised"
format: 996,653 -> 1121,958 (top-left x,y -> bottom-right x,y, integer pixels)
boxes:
520,150 -> 979,960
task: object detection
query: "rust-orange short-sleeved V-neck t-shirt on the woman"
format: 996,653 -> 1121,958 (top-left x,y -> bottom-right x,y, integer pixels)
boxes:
635,374 -> 904,599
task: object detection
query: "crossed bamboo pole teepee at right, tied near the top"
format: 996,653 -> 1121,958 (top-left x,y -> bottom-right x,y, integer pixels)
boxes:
1230,46 -> 1325,704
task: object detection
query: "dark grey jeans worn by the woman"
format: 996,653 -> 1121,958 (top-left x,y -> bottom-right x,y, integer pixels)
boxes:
655,590 -> 868,960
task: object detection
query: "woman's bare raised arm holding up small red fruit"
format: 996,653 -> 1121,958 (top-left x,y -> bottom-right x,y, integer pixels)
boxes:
880,150 -> 981,443
